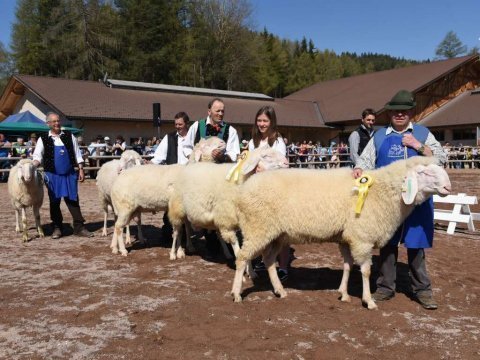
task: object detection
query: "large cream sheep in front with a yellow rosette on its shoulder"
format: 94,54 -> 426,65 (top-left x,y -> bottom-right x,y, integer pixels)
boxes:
232,157 -> 451,309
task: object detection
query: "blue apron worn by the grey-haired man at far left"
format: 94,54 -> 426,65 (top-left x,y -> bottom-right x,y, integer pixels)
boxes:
45,145 -> 78,201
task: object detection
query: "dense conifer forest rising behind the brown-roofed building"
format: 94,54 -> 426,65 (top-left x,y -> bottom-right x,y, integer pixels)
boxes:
0,0 -> 424,97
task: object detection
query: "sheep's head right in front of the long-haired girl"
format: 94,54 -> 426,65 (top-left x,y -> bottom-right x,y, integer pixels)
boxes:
242,146 -> 288,175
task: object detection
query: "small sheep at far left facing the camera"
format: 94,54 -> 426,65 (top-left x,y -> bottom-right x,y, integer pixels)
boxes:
8,159 -> 45,242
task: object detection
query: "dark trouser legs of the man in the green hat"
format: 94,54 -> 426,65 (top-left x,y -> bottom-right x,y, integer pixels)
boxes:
377,246 -> 432,295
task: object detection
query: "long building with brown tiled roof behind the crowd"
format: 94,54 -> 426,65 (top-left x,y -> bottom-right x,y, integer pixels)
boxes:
0,55 -> 480,144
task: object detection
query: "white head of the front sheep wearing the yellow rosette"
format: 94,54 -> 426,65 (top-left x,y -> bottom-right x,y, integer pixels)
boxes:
402,157 -> 452,205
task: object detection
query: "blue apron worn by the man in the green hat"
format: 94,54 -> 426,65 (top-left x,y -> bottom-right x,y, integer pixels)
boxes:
375,132 -> 433,249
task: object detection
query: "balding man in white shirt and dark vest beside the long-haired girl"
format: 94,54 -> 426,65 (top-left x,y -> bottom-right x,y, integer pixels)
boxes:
184,98 -> 240,256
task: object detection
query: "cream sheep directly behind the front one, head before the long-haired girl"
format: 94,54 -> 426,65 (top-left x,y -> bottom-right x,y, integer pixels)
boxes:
168,147 -> 288,264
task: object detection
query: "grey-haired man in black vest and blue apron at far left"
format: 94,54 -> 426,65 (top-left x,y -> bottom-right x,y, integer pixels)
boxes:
33,112 -> 93,239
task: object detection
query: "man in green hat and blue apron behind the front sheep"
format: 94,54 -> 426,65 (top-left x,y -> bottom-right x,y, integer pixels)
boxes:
353,90 -> 446,310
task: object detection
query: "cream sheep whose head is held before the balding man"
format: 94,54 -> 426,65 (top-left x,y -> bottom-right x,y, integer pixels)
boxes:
111,137 -> 226,256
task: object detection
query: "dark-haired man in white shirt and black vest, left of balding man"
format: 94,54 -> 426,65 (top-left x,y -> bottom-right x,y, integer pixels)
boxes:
151,111 -> 190,165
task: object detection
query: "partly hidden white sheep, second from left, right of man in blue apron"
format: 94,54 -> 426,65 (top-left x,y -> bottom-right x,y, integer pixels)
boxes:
97,150 -> 143,243
